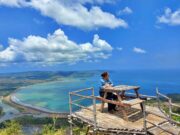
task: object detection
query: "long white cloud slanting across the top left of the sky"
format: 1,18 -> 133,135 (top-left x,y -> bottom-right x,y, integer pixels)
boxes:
0,0 -> 128,29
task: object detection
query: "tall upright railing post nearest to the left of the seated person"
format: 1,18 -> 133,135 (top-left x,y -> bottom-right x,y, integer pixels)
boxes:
92,88 -> 97,135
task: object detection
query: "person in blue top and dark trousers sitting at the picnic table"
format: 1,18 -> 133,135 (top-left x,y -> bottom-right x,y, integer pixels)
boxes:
99,72 -> 117,113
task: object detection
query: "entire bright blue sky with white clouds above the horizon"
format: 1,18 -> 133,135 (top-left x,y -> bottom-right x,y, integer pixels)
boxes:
0,0 -> 180,72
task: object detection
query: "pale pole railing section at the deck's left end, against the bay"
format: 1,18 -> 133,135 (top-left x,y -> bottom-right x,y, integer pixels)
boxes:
69,87 -> 97,135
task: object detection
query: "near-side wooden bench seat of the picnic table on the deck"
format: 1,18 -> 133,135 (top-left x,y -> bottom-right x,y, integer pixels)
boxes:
96,96 -> 144,120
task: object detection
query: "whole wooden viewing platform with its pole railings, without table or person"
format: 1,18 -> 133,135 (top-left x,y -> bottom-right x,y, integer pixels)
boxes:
69,88 -> 180,135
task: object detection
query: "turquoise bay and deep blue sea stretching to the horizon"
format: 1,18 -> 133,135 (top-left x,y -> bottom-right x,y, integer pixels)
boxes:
15,70 -> 180,112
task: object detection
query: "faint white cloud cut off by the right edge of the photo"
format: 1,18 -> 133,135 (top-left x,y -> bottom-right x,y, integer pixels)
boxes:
157,8 -> 180,25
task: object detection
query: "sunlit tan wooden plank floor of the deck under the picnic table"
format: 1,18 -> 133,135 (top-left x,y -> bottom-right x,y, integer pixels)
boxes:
71,104 -> 180,135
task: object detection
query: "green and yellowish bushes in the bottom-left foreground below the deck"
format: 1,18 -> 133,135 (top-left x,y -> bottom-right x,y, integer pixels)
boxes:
0,116 -> 86,135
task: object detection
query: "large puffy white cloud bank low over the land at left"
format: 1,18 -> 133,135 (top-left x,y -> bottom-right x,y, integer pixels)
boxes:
0,29 -> 113,65
